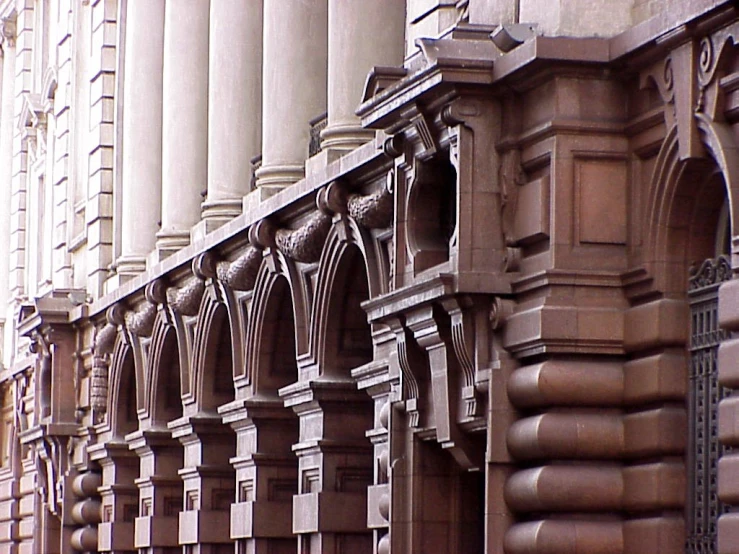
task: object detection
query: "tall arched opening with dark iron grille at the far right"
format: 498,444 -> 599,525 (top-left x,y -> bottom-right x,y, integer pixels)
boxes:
682,161 -> 731,554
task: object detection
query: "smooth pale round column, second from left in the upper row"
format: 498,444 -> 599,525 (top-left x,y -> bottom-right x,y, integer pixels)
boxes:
157,0 -> 210,257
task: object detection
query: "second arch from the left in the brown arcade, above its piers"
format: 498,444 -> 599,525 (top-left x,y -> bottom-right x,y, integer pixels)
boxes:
144,311 -> 187,425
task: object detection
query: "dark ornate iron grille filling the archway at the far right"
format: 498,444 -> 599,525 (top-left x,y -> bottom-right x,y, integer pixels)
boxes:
685,256 -> 731,554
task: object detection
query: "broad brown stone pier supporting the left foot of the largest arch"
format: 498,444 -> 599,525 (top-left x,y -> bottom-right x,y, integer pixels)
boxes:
280,381 -> 374,554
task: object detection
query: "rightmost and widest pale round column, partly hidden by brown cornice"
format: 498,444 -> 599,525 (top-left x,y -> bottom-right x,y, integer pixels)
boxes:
321,0 -> 405,150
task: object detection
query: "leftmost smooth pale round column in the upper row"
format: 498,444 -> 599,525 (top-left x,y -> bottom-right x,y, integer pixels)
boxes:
117,0 -> 164,275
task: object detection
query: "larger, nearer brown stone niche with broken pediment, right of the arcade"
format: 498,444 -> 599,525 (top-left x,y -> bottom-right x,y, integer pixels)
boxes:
357,33 -> 515,293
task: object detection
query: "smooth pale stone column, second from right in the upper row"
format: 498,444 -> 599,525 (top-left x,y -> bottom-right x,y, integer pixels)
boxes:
257,0 -> 328,195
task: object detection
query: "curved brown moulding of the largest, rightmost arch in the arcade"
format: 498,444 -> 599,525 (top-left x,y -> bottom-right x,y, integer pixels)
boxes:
310,218 -> 382,374
